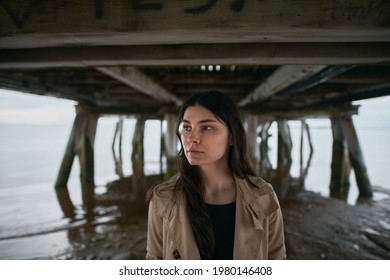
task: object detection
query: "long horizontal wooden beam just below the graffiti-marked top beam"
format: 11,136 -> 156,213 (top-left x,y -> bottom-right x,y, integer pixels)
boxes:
0,42 -> 390,69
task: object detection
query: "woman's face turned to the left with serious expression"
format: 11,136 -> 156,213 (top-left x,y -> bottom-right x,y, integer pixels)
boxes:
181,105 -> 230,166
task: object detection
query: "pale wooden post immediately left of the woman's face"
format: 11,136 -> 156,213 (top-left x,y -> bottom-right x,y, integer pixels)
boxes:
164,114 -> 177,178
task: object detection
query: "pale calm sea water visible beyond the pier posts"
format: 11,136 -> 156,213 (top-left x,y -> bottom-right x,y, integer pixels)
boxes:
0,99 -> 390,259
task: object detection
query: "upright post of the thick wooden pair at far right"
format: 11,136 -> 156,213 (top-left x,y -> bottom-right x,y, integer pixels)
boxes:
329,118 -> 351,200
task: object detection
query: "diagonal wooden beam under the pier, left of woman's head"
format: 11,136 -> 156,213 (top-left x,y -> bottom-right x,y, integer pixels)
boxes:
96,67 -> 183,106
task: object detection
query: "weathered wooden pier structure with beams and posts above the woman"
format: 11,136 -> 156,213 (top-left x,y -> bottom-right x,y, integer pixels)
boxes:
0,0 -> 390,217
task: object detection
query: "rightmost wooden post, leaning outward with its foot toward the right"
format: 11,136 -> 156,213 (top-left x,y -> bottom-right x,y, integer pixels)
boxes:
340,117 -> 373,197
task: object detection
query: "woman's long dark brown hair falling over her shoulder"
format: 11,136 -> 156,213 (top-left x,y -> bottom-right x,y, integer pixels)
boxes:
176,92 -> 255,259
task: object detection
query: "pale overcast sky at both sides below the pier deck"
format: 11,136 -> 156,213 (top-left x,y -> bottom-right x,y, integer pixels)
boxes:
0,89 -> 390,128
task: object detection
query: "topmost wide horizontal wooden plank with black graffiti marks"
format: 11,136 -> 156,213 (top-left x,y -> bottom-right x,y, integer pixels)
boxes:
0,0 -> 390,47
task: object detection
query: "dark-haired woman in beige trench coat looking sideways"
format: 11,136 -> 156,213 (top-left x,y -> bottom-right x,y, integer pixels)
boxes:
146,92 -> 286,259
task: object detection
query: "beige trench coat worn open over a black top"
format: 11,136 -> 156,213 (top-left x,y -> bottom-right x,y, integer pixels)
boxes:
146,177 -> 286,260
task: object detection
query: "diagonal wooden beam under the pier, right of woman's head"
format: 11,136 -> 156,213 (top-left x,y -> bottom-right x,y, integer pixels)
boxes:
238,65 -> 326,107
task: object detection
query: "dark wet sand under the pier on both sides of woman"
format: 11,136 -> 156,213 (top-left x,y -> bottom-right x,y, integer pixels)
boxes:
10,178 -> 390,260
